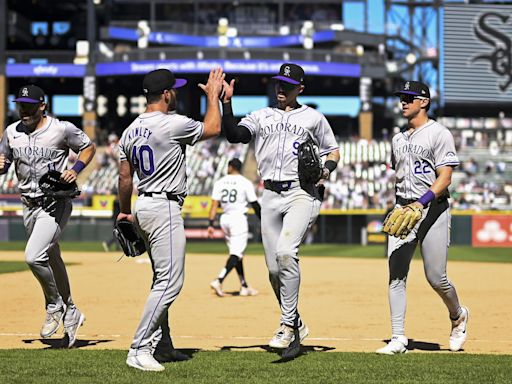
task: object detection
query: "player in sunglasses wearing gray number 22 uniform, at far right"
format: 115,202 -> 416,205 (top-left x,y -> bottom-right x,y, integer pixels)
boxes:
377,81 -> 469,355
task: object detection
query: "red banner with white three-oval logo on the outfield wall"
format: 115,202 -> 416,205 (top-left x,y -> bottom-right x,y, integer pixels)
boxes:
472,215 -> 512,247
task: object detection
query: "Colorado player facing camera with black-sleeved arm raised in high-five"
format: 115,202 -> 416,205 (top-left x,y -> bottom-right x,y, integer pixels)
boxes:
222,63 -> 340,349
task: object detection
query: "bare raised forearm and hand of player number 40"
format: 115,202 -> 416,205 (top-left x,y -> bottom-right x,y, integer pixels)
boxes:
199,67 -> 225,140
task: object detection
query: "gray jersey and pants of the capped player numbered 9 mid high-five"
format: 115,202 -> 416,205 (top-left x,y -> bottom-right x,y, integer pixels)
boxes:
239,105 -> 338,326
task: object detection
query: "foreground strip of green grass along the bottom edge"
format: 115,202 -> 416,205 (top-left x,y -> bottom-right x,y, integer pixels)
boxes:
0,349 -> 512,384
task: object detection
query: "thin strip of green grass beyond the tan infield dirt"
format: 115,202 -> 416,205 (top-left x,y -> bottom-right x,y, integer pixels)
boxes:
0,241 -> 512,263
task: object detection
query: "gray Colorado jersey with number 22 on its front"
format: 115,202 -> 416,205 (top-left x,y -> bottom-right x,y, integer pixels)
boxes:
391,120 -> 459,199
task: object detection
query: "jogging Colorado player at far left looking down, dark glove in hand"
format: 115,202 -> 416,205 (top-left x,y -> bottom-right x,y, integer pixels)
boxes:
0,85 -> 95,347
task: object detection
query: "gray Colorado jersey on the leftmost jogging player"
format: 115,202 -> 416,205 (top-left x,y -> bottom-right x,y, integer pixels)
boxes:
0,117 -> 91,197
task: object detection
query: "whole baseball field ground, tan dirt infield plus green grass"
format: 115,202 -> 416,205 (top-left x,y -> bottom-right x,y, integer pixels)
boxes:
0,243 -> 512,383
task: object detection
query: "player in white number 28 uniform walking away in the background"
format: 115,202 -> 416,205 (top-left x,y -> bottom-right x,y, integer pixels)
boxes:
208,158 -> 261,297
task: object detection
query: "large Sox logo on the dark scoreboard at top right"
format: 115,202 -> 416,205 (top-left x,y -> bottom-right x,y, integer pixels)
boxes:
471,12 -> 512,92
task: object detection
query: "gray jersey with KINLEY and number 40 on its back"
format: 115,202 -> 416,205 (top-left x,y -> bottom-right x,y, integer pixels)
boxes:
119,112 -> 204,195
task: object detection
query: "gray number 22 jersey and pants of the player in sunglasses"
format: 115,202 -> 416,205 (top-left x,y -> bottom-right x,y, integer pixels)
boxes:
388,120 -> 461,335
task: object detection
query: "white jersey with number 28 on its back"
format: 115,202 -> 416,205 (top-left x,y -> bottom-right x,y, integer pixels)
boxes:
212,175 -> 257,214
